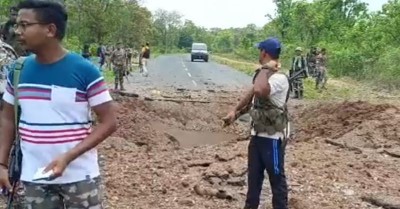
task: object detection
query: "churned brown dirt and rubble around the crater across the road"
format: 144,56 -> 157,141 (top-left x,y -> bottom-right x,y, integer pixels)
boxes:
100,92 -> 400,209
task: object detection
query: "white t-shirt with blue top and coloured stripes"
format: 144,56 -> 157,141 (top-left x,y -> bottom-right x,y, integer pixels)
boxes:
3,53 -> 112,184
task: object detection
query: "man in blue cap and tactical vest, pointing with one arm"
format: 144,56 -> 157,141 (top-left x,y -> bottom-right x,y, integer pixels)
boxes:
223,38 -> 289,209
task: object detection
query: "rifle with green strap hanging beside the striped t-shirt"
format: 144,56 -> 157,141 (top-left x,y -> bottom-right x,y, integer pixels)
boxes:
7,57 -> 24,209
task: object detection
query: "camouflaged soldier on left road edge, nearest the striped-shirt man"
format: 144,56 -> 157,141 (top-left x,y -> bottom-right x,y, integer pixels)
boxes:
111,43 -> 126,91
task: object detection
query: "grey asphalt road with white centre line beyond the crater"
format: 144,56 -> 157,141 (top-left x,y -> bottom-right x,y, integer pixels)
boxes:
128,54 -> 251,91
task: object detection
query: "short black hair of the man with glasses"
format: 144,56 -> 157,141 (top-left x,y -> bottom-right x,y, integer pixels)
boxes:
18,0 -> 68,40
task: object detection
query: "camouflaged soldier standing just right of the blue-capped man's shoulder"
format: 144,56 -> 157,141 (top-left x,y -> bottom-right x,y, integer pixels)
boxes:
289,47 -> 308,99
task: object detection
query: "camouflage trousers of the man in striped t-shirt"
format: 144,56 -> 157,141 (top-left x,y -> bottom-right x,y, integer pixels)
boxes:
24,177 -> 103,209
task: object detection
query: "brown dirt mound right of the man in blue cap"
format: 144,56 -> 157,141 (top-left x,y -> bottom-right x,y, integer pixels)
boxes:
295,101 -> 399,140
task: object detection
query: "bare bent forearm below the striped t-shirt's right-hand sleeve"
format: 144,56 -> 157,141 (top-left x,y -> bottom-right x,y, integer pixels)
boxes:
66,101 -> 117,163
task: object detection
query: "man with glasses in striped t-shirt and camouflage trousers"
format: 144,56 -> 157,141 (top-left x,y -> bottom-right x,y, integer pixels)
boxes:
0,1 -> 116,209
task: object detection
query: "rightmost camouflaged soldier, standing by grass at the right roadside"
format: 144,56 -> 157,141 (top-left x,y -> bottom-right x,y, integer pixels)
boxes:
315,48 -> 328,89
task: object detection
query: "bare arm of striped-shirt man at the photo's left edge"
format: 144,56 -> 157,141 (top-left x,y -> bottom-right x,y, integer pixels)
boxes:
0,101 -> 15,165
